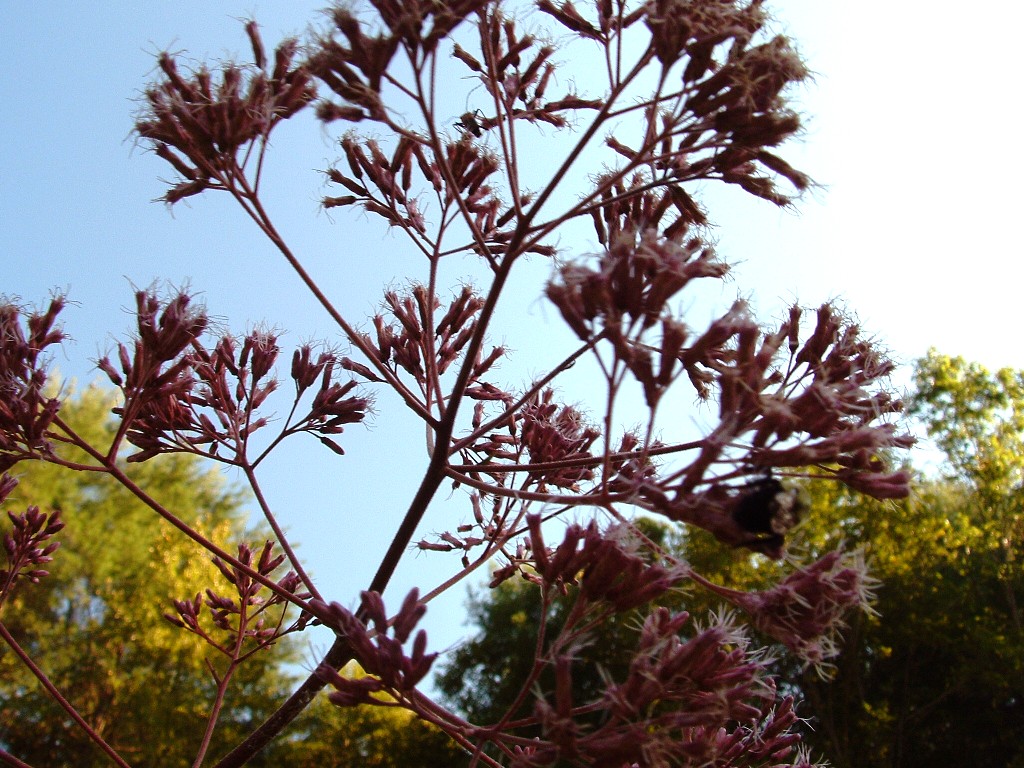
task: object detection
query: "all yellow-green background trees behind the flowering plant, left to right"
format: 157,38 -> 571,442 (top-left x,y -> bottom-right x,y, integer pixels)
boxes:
0,370 -> 1024,768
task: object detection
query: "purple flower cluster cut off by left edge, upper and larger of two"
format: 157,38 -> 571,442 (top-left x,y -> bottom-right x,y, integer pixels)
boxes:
0,296 -> 65,472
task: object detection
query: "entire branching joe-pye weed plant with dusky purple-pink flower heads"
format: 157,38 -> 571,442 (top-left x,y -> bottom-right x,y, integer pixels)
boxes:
0,0 -> 909,768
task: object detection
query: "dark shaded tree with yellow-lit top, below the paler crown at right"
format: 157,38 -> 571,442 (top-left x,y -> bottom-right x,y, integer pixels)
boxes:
788,482 -> 1024,768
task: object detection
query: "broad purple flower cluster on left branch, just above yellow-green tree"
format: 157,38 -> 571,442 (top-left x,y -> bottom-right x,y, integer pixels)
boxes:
97,291 -> 369,464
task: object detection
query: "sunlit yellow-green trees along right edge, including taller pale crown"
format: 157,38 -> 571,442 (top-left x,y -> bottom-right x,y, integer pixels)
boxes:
799,350 -> 1024,768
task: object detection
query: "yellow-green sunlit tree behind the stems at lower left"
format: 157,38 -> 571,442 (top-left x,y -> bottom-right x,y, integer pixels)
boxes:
0,388 -> 291,766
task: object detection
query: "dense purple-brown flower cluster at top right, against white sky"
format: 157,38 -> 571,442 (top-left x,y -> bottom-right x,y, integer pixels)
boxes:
538,0 -> 810,234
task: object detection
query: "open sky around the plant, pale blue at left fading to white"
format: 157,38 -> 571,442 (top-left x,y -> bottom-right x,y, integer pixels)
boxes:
0,0 -> 1024,684
